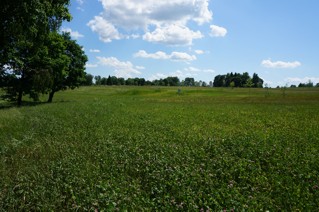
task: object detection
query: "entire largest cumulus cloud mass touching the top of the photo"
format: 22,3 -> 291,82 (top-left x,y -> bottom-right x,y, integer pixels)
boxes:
88,0 -> 212,45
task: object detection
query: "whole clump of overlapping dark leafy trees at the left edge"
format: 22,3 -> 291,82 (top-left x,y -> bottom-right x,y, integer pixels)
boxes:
0,0 -> 87,105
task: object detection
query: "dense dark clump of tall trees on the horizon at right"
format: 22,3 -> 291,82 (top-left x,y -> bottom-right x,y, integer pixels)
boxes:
213,72 -> 264,88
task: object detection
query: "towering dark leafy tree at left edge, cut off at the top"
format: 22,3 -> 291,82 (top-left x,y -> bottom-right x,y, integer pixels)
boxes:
0,0 -> 71,105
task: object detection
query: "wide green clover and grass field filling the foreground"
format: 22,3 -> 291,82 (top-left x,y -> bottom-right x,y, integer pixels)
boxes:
0,87 -> 319,211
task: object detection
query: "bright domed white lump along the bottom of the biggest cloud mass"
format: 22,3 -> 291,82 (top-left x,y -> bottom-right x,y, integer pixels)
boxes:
143,24 -> 203,46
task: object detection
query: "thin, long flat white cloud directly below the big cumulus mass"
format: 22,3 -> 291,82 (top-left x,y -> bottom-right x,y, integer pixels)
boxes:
134,50 -> 197,62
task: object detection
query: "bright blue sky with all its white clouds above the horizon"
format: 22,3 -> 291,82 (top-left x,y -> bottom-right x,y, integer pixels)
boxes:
62,0 -> 319,87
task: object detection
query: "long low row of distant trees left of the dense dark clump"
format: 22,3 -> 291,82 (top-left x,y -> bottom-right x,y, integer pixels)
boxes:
82,74 -> 213,87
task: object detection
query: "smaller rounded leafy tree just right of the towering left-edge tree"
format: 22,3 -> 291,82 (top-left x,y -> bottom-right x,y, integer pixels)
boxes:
48,33 -> 87,102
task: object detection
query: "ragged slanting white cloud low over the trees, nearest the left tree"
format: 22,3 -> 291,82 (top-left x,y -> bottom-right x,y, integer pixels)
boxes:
96,57 -> 141,78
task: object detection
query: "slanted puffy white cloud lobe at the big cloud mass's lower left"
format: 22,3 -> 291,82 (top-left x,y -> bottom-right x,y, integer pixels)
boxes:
87,16 -> 121,43
